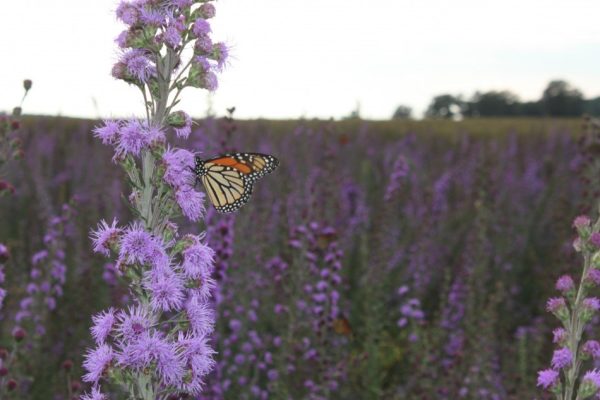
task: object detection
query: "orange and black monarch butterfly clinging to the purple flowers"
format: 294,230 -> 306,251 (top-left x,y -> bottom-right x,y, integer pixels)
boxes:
194,153 -> 279,213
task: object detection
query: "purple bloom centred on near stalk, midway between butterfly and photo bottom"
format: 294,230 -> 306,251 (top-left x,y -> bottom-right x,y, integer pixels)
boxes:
144,266 -> 185,311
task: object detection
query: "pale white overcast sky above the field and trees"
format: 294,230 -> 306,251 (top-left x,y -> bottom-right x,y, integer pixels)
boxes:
0,0 -> 600,119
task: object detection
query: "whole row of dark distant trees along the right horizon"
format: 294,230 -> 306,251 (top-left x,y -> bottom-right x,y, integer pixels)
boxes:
392,80 -> 600,119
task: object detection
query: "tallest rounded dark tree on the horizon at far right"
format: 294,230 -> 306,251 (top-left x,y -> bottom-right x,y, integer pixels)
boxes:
540,80 -> 583,117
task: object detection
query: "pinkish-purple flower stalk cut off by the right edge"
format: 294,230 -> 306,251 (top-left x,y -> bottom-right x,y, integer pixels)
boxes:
538,212 -> 600,400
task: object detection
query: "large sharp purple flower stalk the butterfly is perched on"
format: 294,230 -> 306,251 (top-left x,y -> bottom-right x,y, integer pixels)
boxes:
83,0 -> 227,400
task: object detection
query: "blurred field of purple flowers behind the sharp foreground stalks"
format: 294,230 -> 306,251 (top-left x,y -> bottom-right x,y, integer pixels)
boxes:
0,113 -> 598,400
